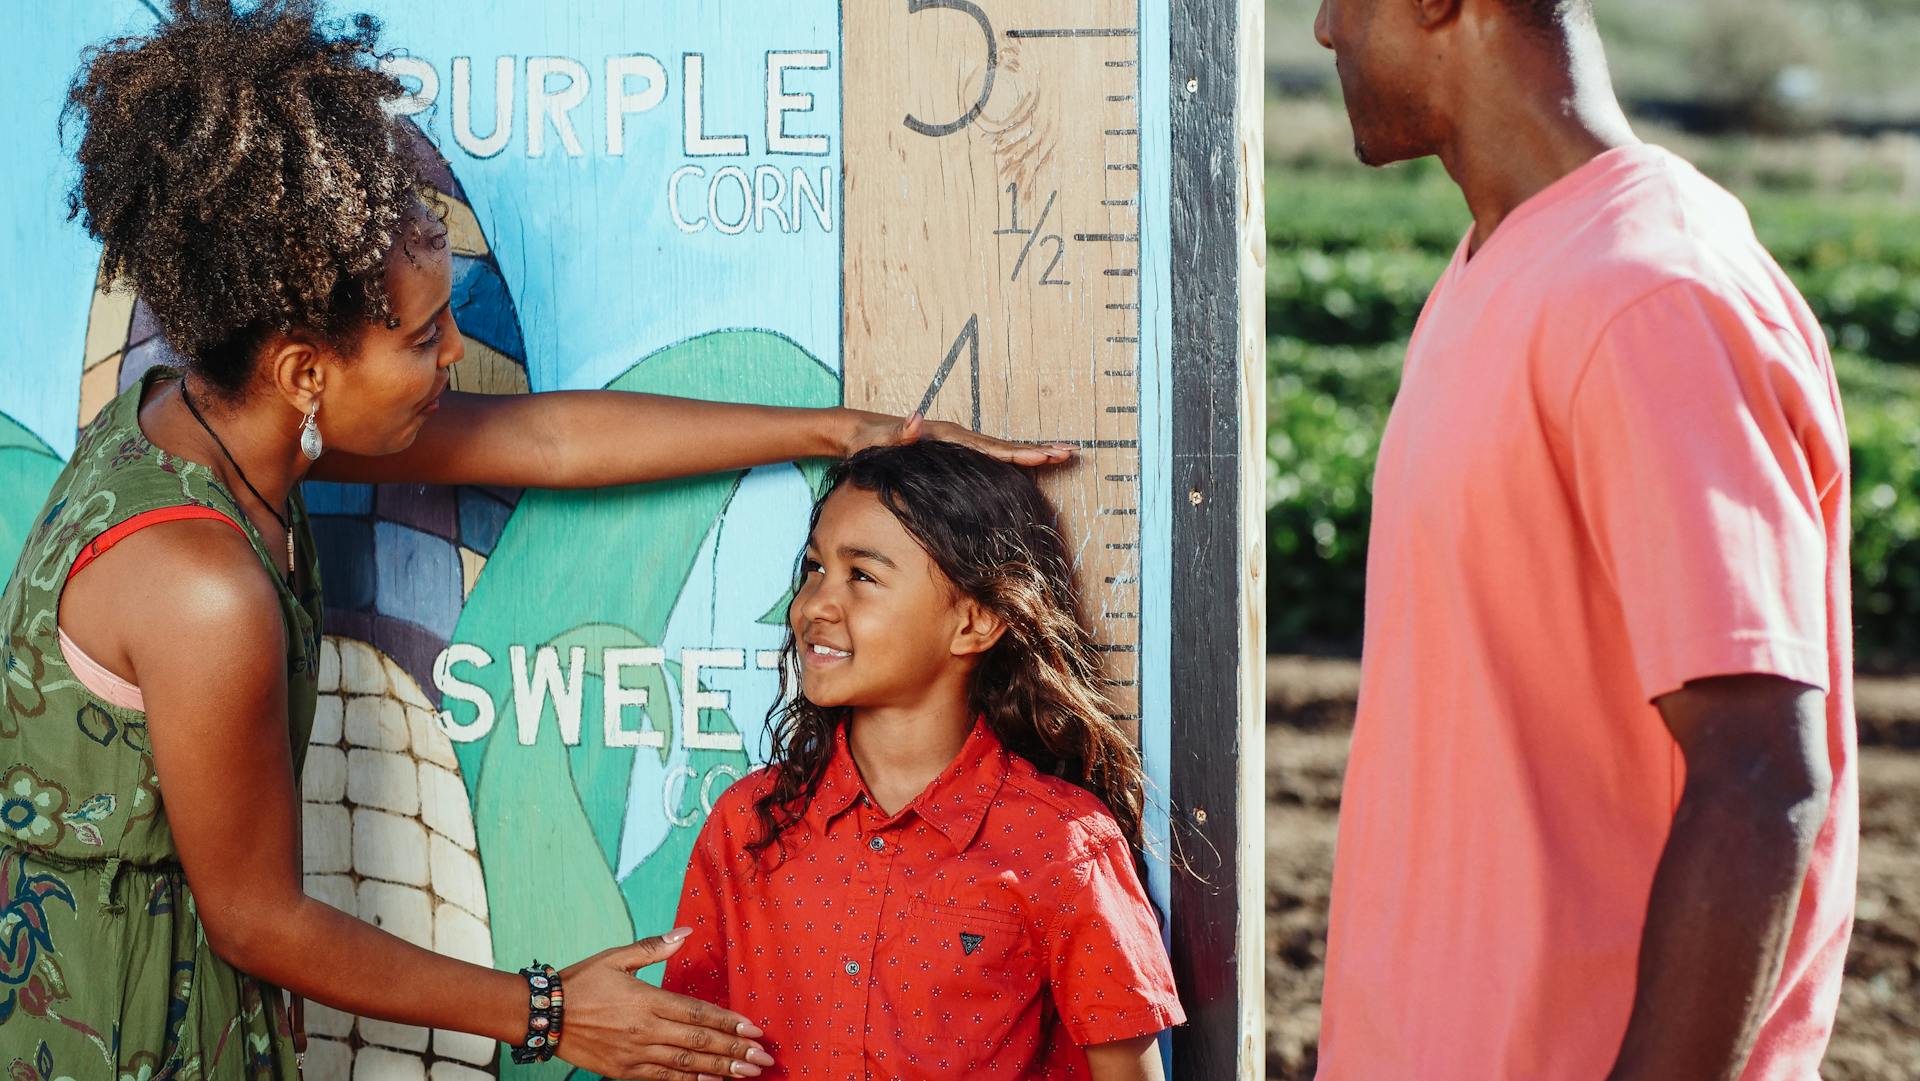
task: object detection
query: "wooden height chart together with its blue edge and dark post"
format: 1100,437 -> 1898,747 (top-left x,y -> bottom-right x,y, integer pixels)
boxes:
841,0 -> 1263,1079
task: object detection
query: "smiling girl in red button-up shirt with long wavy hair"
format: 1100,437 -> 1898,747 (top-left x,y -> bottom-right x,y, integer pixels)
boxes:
666,442 -> 1185,1081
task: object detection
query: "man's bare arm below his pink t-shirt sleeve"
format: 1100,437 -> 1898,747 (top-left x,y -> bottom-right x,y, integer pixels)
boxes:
1607,676 -> 1832,1081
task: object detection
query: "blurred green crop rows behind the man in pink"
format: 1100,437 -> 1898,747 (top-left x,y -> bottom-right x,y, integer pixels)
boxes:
1267,165 -> 1920,668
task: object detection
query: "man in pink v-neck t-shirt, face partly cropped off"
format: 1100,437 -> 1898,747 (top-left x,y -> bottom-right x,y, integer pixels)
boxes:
1315,0 -> 1859,1081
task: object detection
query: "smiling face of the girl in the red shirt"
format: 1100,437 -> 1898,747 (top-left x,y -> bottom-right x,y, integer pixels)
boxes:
787,484 -> 1000,709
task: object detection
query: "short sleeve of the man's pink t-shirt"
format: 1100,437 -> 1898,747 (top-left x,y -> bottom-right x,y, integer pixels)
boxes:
1567,282 -> 1845,701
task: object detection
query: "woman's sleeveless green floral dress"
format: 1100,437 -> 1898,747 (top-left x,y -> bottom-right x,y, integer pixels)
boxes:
0,369 -> 321,1081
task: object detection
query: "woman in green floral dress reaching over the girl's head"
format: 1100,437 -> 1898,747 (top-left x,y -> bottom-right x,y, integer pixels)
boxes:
0,0 -> 1068,1081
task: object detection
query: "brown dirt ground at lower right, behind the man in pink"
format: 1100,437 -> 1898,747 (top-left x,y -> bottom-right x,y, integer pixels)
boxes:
1267,659 -> 1920,1081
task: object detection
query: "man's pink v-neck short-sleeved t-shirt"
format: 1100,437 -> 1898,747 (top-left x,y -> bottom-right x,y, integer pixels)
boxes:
1319,146 -> 1859,1081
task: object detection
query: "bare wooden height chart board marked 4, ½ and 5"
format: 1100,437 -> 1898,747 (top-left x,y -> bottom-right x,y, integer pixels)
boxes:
843,0 -> 1140,722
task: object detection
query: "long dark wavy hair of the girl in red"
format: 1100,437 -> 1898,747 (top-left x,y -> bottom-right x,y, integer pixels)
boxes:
747,440 -> 1146,858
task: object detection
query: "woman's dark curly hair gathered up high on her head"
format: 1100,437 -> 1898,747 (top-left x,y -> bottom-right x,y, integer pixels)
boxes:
61,0 -> 420,396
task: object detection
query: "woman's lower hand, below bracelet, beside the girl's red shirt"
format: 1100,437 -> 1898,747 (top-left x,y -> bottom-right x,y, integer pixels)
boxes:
559,927 -> 774,1081
